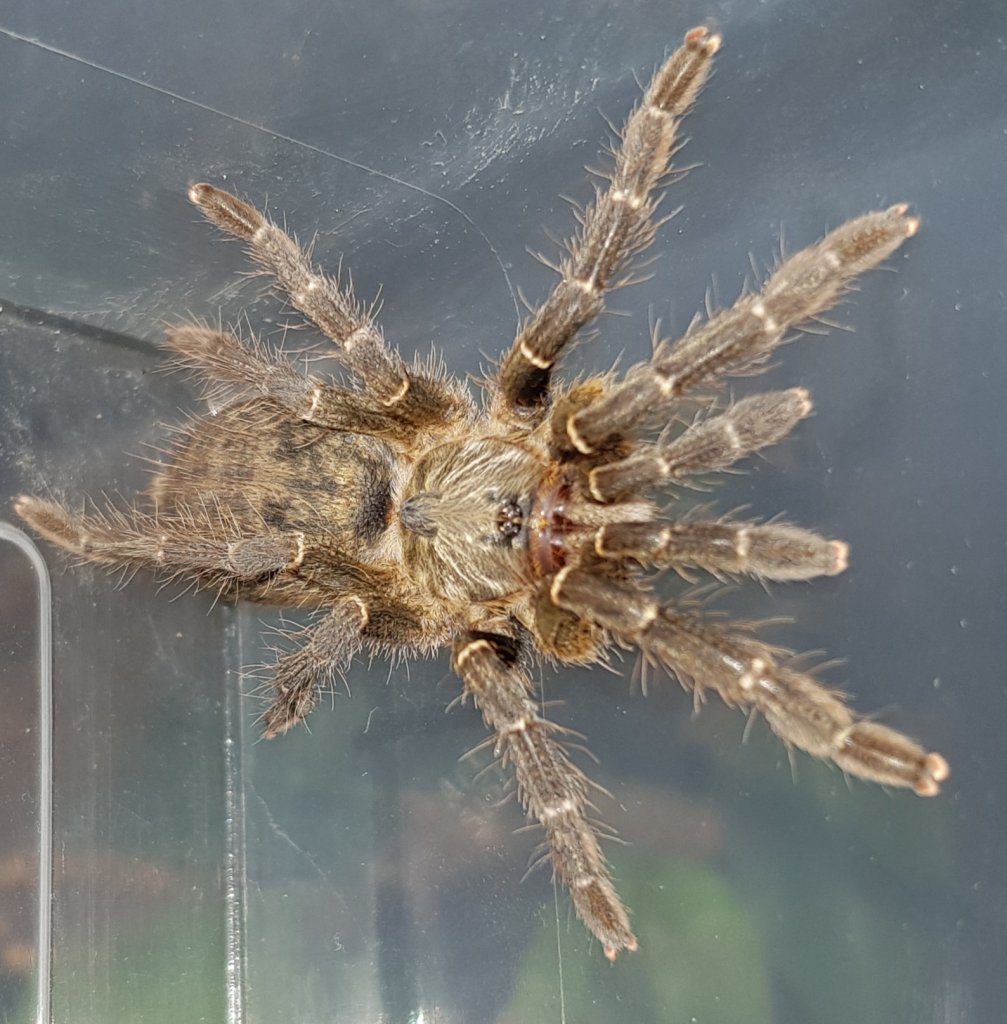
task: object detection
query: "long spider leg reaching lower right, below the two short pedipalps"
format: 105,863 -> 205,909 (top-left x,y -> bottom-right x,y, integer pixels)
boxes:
551,566 -> 949,797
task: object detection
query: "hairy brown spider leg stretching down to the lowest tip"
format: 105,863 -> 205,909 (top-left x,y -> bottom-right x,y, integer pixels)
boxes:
454,632 -> 636,959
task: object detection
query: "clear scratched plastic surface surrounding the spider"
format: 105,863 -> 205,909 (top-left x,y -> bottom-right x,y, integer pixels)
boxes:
0,0 -> 1007,1024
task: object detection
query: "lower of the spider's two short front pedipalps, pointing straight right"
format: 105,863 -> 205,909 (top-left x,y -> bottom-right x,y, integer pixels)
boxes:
594,519 -> 848,583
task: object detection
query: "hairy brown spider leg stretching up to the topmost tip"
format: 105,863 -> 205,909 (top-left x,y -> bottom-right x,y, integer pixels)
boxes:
494,28 -> 720,424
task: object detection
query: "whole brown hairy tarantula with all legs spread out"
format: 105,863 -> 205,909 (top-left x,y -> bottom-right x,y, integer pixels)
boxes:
16,28 -> 949,959
